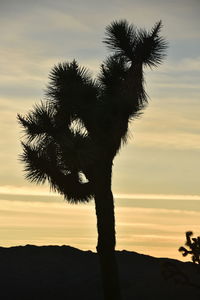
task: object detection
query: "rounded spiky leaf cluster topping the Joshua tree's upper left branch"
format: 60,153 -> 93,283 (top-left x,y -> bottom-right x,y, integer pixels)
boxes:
46,60 -> 98,112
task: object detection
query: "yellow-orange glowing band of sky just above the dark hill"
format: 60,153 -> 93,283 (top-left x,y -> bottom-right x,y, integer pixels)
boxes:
0,200 -> 200,260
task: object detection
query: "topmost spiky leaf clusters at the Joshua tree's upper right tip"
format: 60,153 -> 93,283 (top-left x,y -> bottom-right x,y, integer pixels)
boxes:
104,20 -> 167,67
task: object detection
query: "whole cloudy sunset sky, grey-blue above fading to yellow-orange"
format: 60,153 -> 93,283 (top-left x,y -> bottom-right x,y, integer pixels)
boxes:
0,0 -> 200,259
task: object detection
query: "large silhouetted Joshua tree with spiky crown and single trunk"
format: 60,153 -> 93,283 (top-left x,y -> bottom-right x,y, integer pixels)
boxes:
18,20 -> 166,300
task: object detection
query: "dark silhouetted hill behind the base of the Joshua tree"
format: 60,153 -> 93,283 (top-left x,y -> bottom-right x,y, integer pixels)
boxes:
0,245 -> 200,300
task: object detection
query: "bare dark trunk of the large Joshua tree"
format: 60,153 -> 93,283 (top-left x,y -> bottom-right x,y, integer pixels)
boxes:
95,162 -> 121,300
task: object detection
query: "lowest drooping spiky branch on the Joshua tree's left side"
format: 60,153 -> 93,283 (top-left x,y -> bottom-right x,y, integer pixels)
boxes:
21,143 -> 93,202
